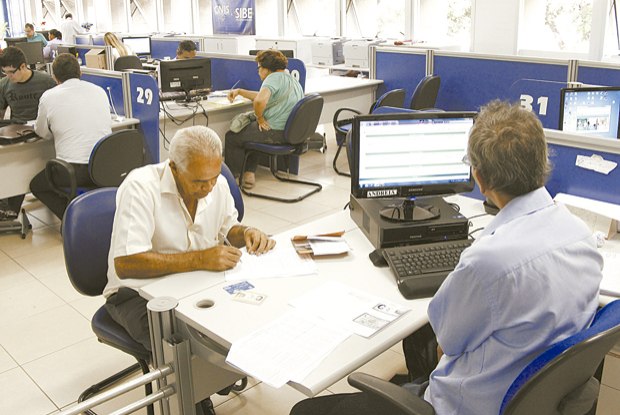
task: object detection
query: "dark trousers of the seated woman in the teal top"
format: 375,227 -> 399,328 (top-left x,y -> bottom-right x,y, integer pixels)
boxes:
224,121 -> 285,177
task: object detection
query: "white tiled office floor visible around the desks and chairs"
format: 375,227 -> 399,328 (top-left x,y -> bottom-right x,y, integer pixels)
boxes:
0,128 -> 404,415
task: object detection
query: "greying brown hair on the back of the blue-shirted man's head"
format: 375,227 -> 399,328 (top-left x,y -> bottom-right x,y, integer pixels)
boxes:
467,100 -> 551,197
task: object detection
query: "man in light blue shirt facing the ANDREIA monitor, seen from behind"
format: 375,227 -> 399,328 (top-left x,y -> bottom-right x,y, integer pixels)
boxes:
291,101 -> 603,415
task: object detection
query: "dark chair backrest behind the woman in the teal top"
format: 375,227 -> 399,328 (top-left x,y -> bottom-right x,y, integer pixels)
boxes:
284,94 -> 323,145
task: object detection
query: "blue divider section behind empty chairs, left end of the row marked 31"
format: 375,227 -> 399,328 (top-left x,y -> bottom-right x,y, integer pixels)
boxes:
375,47 -> 426,106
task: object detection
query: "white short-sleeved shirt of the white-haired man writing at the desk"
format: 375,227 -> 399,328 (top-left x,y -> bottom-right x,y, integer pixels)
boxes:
103,160 -> 239,297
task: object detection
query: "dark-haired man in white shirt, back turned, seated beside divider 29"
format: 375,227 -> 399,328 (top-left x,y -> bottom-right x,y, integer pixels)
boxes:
30,53 -> 112,219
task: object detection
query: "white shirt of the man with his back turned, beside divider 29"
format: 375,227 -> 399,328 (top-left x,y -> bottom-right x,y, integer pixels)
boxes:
35,78 -> 112,164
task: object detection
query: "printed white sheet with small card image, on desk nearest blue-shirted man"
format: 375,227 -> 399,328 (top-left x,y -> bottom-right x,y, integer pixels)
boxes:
290,281 -> 408,337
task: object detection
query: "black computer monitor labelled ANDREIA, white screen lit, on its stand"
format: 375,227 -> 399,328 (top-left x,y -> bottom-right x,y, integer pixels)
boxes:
351,112 -> 476,221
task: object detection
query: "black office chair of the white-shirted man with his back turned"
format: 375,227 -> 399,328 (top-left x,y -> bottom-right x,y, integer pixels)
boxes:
45,130 -> 145,202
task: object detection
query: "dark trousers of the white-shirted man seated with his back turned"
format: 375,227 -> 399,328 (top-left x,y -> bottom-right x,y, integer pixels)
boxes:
30,163 -> 95,220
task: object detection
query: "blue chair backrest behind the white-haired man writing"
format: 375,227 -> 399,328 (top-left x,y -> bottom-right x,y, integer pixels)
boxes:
62,187 -> 116,296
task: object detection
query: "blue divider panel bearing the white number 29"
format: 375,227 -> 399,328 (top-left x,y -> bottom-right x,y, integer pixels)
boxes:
128,73 -> 159,163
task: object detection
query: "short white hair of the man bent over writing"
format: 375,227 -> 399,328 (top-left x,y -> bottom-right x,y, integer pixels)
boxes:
169,125 -> 222,171
